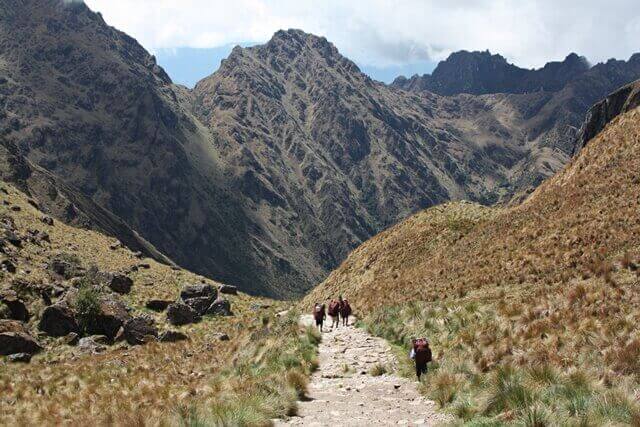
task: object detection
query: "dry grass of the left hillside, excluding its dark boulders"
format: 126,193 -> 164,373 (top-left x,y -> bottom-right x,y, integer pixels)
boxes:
0,183 -> 318,426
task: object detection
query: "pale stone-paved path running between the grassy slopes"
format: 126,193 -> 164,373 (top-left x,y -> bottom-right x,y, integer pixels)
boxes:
275,316 -> 448,426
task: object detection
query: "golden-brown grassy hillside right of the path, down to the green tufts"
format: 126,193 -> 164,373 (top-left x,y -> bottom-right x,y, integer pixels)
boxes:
304,109 -> 640,425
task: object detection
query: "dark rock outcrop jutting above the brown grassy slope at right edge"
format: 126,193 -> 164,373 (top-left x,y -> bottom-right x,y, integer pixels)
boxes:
575,81 -> 640,153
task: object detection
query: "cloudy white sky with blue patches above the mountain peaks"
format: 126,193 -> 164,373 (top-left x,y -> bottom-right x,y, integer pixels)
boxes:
85,0 -> 640,86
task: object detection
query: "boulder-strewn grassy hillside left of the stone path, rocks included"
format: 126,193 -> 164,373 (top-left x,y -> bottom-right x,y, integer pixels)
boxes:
0,182 -> 318,426
